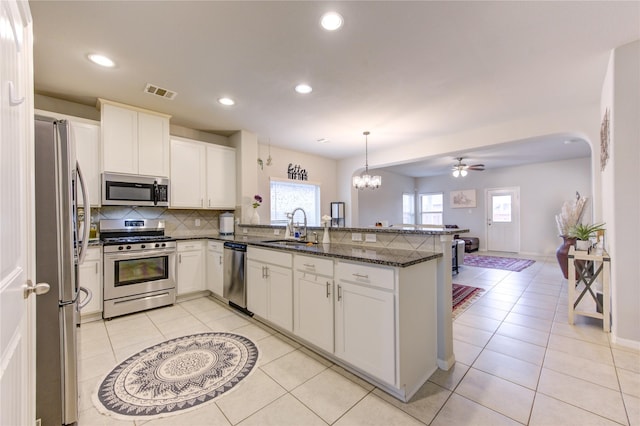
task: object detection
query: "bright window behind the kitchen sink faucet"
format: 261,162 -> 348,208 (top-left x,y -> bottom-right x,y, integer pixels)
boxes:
271,179 -> 320,226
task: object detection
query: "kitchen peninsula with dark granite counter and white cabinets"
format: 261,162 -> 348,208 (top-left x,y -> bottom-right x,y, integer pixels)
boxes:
174,224 -> 466,401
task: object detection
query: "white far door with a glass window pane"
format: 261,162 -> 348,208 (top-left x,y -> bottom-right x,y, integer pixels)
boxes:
486,188 -> 520,253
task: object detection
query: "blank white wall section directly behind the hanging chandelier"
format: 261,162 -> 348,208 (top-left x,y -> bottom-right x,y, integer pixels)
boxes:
357,170 -> 415,226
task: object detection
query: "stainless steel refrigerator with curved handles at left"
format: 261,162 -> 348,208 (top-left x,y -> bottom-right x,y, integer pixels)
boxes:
34,116 -> 90,425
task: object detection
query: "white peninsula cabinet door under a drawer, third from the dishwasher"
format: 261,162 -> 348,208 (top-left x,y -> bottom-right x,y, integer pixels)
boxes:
293,271 -> 333,353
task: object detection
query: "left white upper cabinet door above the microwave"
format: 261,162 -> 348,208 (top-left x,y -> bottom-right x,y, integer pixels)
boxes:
101,103 -> 138,174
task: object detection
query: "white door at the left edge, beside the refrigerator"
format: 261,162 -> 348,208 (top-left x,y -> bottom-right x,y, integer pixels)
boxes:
0,0 -> 35,425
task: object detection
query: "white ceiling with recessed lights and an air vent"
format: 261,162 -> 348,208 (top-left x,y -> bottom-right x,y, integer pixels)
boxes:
30,1 -> 640,175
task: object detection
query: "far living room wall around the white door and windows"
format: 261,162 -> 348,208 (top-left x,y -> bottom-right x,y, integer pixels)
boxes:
359,157 -> 593,255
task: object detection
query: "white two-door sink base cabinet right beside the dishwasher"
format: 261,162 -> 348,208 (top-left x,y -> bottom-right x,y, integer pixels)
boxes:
247,246 -> 293,331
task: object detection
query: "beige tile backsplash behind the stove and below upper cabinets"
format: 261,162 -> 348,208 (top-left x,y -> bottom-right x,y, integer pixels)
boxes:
91,206 -> 227,236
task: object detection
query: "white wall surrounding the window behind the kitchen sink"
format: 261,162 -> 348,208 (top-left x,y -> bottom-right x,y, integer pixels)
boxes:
254,144 -> 338,225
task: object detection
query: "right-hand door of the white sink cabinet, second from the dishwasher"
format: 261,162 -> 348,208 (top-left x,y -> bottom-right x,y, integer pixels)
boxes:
266,265 -> 293,331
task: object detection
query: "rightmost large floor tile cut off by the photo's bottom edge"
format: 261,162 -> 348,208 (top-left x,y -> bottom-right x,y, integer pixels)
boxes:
529,393 -> 618,426
